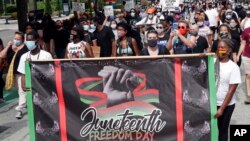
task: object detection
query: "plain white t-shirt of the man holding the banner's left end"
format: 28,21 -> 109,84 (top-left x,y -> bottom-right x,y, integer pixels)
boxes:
17,50 -> 53,74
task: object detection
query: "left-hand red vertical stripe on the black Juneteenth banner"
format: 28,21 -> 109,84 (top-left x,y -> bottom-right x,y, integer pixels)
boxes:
54,60 -> 68,141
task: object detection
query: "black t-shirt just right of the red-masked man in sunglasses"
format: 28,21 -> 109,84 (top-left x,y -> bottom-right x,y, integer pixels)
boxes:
193,36 -> 208,53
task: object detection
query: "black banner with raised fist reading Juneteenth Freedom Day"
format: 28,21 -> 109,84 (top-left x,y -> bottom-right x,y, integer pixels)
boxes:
26,55 -> 218,141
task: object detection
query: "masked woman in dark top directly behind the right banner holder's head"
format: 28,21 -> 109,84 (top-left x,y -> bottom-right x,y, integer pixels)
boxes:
211,24 -> 236,62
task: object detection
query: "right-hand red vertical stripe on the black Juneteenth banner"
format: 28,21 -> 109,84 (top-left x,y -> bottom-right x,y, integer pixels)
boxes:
174,58 -> 184,141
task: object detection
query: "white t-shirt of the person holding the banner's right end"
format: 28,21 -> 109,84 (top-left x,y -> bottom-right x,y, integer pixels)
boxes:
216,60 -> 241,106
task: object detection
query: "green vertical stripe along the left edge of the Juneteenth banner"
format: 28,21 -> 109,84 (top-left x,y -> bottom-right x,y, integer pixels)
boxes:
25,62 -> 36,141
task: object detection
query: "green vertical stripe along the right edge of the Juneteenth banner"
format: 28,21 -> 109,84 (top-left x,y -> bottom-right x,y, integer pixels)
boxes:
208,56 -> 218,141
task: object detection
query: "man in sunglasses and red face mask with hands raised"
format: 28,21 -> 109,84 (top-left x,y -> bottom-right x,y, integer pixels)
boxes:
167,20 -> 196,54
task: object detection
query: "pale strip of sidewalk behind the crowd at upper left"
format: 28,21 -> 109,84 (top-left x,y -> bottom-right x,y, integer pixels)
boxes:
0,14 -> 73,31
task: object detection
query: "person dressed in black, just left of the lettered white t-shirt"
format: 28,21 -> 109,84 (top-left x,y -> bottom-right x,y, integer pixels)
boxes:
53,20 -> 70,59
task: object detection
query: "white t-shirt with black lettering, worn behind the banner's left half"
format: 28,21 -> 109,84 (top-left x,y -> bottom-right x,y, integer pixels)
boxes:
67,41 -> 86,58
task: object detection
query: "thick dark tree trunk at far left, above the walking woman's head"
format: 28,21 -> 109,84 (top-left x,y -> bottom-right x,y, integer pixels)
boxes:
16,0 -> 27,32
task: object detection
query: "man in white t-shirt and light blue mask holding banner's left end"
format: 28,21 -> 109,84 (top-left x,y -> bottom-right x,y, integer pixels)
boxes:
16,31 -> 53,119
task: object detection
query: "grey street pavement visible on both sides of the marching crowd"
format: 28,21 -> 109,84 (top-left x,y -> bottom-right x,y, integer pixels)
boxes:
0,16 -> 250,141
